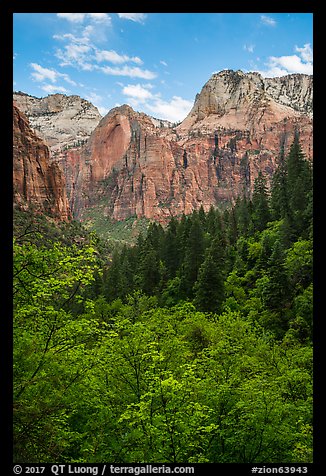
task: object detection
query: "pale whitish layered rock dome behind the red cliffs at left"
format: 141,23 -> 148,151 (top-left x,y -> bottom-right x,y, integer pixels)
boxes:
14,92 -> 101,152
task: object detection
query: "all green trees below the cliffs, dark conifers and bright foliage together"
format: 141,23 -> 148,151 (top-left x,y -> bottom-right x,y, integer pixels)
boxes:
13,137 -> 313,463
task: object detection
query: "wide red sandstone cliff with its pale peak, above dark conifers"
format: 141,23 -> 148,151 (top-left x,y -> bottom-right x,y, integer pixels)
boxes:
67,71 -> 312,222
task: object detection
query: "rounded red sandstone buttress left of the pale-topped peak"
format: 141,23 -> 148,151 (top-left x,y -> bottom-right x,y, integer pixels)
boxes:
74,105 -> 186,220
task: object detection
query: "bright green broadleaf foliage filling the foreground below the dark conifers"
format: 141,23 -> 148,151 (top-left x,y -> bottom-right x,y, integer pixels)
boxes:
14,233 -> 311,463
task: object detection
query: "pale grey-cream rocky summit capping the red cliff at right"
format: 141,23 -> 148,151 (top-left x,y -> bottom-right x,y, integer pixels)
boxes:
179,70 -> 313,131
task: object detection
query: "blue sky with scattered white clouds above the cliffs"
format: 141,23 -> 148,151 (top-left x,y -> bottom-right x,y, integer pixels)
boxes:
13,13 -> 313,122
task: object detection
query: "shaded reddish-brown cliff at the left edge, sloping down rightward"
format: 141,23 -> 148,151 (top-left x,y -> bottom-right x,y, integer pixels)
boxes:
13,105 -> 71,221
